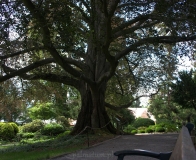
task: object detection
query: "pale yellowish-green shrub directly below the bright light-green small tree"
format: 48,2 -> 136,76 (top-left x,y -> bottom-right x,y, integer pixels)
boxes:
22,119 -> 44,132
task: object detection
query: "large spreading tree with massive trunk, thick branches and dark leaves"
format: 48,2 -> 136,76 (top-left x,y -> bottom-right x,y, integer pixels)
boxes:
0,0 -> 196,134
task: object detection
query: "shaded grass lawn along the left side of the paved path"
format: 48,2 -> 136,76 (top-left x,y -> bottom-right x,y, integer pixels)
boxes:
0,134 -> 114,160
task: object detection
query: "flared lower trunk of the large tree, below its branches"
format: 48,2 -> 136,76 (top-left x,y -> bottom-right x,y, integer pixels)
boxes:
72,83 -> 116,134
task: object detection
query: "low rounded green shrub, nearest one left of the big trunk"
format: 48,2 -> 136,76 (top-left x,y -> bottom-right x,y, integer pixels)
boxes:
41,123 -> 65,135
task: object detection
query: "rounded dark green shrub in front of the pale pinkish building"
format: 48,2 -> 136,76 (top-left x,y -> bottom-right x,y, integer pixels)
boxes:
133,118 -> 155,128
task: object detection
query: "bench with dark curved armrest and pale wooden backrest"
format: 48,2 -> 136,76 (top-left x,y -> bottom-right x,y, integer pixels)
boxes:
114,126 -> 196,160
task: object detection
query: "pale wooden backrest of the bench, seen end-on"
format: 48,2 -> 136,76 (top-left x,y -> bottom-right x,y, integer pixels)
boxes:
170,126 -> 196,160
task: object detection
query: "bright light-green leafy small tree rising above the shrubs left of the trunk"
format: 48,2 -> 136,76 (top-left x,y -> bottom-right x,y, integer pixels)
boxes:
29,103 -> 56,120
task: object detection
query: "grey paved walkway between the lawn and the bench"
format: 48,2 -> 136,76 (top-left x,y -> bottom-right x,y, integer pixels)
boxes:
49,134 -> 178,160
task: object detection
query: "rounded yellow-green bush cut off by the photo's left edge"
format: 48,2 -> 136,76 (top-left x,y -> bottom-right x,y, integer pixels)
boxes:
0,123 -> 15,140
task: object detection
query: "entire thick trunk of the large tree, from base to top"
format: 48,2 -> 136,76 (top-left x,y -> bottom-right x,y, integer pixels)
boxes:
72,1 -> 117,134
